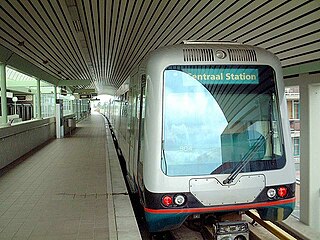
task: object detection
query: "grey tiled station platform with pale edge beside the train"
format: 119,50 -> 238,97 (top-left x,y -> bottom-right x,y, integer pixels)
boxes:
0,114 -> 141,240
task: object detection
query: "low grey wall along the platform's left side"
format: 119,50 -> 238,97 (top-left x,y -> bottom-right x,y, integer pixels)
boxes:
0,118 -> 56,169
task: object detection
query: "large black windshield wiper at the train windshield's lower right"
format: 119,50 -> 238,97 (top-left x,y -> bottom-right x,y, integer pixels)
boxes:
223,135 -> 269,184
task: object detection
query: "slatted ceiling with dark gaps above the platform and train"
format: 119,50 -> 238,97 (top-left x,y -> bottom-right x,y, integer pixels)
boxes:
0,0 -> 320,93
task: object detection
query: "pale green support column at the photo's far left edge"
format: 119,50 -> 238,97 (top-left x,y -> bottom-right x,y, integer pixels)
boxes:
0,63 -> 8,125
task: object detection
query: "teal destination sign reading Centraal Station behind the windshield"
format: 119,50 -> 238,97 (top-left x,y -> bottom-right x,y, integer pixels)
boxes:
181,67 -> 259,84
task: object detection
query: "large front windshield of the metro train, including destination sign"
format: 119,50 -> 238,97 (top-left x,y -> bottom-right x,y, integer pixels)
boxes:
161,65 -> 285,176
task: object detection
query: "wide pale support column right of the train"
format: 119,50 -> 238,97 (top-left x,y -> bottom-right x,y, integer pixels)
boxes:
299,76 -> 320,231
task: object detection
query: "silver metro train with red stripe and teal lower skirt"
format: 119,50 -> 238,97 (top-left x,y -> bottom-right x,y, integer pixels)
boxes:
105,42 -> 296,232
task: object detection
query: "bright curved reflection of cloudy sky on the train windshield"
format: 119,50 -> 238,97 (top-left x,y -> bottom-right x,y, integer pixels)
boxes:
163,70 -> 227,175
